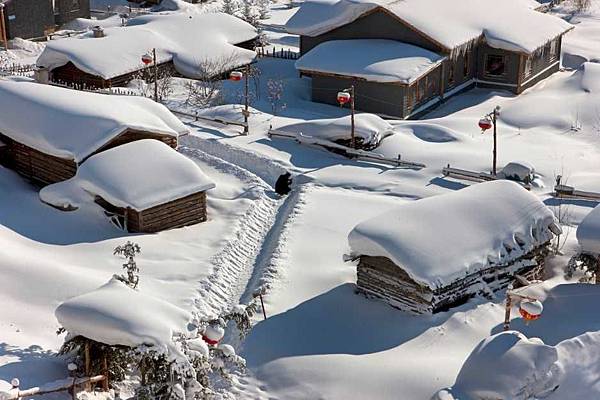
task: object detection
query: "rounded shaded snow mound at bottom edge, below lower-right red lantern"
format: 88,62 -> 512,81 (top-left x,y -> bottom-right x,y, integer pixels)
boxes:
432,331 -> 564,400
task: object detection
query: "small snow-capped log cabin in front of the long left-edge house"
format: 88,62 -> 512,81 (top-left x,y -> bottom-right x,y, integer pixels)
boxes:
40,139 -> 215,233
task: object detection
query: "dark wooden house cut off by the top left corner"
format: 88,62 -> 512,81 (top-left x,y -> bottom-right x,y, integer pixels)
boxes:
4,0 -> 90,39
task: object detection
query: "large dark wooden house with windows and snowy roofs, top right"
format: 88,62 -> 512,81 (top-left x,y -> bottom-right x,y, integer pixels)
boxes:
286,0 -> 573,118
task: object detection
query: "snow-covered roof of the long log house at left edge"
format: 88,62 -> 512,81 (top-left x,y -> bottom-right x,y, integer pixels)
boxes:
0,80 -> 188,162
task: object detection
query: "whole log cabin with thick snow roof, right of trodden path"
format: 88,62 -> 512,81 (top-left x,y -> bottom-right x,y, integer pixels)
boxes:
349,181 -> 561,313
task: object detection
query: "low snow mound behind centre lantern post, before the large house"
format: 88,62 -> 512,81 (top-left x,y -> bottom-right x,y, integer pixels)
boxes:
280,113 -> 394,147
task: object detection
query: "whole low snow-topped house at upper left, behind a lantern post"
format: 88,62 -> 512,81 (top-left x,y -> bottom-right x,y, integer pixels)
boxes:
36,13 -> 258,88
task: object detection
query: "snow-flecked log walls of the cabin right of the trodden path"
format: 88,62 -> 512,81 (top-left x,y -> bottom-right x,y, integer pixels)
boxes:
357,244 -> 549,314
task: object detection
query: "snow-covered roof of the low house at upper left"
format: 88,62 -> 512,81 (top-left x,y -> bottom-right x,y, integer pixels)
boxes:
37,13 -> 257,79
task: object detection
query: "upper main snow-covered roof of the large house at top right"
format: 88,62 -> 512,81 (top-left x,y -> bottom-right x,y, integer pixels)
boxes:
286,0 -> 573,54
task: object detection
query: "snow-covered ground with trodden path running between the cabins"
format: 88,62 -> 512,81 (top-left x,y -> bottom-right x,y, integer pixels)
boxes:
0,0 -> 600,400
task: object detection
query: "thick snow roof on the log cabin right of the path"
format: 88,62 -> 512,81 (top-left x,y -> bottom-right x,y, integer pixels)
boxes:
349,180 -> 556,289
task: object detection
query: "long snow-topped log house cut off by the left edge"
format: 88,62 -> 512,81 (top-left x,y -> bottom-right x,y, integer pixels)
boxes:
0,81 -> 187,185
